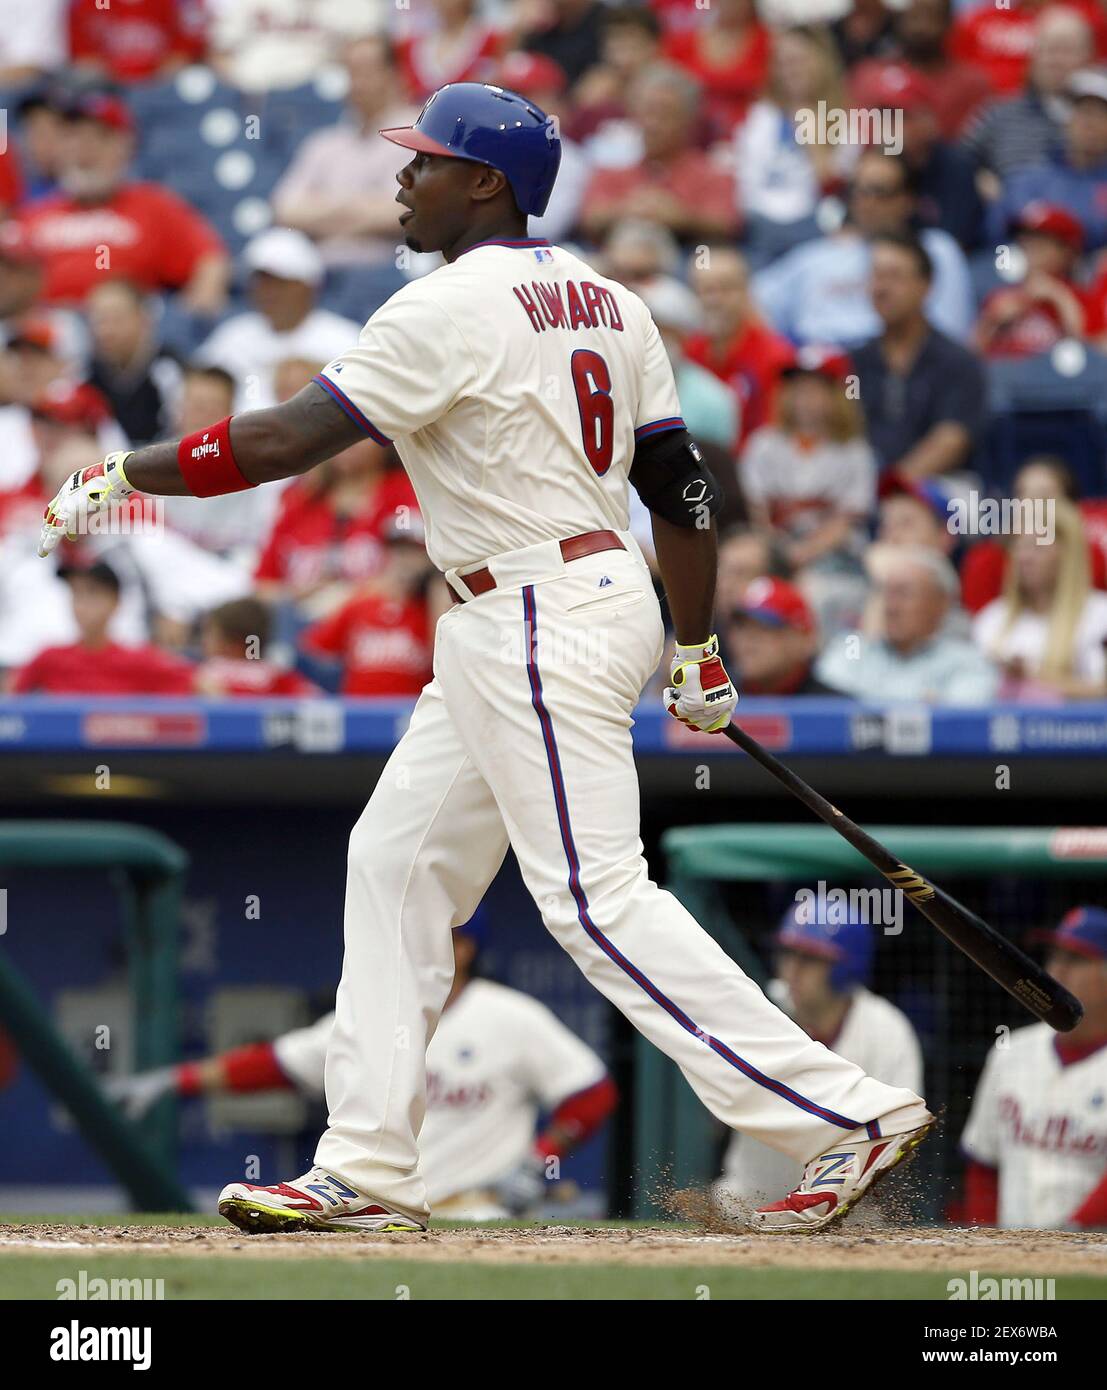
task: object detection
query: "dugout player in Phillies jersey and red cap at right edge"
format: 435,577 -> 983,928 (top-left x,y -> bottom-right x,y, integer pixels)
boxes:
961,908 -> 1107,1230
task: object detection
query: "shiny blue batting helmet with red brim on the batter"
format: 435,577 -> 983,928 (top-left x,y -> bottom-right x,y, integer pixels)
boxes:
381,82 -> 562,217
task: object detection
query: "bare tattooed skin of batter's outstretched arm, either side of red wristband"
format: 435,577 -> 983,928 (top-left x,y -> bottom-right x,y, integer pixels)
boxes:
127,382 -> 364,498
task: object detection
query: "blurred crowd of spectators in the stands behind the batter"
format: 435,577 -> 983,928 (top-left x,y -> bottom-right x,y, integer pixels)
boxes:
0,0 -> 1107,705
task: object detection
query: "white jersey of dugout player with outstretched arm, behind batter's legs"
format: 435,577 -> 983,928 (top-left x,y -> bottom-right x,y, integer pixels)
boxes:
273,980 -> 606,1207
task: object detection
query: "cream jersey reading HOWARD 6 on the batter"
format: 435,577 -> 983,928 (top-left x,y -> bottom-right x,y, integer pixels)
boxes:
316,239 -> 683,570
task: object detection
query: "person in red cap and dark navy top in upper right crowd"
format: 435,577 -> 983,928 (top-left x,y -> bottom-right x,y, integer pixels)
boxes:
872,64 -> 985,250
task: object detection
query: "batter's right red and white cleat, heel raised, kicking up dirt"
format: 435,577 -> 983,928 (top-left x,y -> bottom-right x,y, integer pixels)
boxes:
750,1116 -> 935,1234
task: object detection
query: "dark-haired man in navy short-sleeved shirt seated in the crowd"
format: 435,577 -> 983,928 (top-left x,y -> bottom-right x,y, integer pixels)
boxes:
853,235 -> 986,478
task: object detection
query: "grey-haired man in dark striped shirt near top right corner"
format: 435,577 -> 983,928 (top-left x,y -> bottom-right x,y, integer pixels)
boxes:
961,6 -> 1094,189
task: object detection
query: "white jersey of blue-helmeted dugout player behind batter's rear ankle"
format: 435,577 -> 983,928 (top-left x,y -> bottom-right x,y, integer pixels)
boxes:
719,987 -> 922,1200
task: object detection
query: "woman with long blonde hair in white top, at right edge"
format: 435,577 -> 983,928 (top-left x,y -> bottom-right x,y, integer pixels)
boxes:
972,499 -> 1107,701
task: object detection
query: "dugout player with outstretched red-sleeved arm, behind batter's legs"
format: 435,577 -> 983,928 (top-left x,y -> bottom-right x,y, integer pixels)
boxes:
106,916 -> 616,1220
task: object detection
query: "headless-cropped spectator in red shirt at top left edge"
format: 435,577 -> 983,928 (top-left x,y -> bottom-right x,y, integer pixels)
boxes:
68,0 -> 204,82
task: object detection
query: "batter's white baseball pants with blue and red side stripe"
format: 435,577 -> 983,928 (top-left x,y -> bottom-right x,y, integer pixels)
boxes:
316,532 -> 926,1218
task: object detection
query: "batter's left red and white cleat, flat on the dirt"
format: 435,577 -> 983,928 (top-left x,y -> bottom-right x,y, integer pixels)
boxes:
220,1168 -> 427,1234
